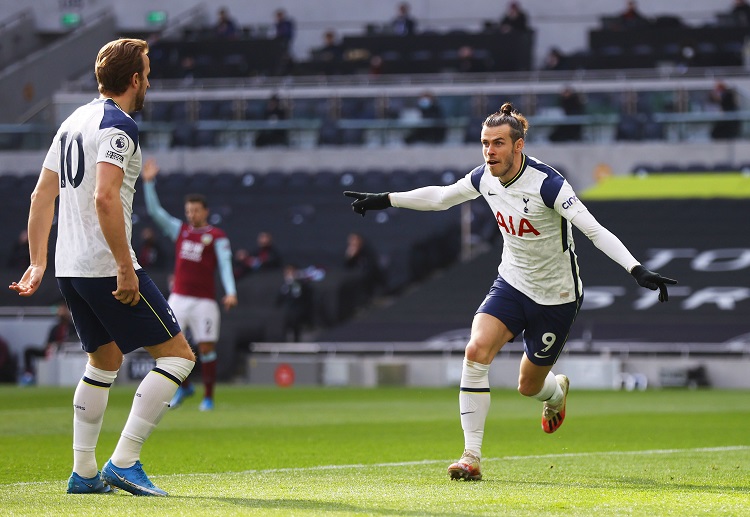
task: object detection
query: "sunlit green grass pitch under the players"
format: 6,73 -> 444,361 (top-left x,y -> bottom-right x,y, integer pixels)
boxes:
0,379 -> 750,517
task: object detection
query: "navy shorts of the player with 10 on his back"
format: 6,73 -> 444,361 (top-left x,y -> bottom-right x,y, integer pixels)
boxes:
57,269 -> 180,354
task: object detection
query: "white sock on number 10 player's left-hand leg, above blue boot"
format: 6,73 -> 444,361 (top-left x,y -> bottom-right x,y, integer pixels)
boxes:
73,364 -> 117,478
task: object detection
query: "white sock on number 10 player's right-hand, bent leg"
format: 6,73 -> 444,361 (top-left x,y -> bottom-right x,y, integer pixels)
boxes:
112,357 -> 195,468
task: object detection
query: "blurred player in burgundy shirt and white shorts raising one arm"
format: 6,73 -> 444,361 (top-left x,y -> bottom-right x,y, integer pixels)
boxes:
141,155 -> 237,411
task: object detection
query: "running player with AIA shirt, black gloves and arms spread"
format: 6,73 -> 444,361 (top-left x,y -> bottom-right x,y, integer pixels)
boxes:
344,103 -> 677,480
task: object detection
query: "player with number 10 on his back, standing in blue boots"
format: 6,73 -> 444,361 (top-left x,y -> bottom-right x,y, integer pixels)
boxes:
10,38 -> 195,496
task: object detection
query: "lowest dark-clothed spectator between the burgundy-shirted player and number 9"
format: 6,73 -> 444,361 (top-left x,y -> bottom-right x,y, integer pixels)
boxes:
276,264 -> 314,342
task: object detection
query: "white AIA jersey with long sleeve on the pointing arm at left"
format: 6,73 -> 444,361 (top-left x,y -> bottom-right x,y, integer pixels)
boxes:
390,155 -> 587,305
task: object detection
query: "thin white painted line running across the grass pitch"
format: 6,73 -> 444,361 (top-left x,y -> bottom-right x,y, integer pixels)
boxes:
0,445 -> 750,488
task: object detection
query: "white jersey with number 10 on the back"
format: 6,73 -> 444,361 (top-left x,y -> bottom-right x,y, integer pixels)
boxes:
44,95 -> 141,278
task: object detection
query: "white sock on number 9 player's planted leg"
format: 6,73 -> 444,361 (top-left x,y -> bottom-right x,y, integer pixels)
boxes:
458,358 -> 490,457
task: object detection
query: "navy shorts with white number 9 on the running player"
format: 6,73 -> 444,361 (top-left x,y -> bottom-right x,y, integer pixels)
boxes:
477,275 -> 583,366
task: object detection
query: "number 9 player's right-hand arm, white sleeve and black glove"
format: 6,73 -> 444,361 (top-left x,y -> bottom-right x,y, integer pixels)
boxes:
570,210 -> 677,302
